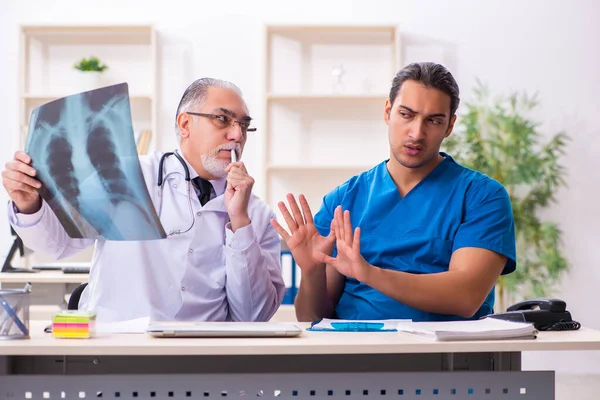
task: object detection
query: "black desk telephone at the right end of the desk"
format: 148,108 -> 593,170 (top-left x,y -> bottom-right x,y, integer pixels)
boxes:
487,298 -> 581,331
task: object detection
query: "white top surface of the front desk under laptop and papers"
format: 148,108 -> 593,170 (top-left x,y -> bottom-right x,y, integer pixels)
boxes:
0,321 -> 600,356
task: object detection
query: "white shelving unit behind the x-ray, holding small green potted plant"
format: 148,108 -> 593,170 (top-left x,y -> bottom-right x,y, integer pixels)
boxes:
19,25 -> 158,153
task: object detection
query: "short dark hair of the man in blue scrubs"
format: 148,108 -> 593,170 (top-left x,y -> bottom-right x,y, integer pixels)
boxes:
390,62 -> 460,116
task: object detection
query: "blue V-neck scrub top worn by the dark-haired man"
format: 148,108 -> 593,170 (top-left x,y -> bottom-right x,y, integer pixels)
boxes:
314,153 -> 516,321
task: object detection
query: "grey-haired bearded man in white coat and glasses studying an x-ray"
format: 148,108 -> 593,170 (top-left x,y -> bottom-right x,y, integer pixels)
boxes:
2,78 -> 285,321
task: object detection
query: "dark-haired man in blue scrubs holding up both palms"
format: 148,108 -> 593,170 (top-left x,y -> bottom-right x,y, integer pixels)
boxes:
271,63 -> 516,321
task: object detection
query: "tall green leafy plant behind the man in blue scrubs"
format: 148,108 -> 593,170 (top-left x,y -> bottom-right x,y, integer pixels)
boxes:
444,82 -> 569,311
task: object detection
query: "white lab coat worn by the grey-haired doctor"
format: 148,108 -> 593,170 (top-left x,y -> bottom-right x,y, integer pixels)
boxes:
9,153 -> 285,321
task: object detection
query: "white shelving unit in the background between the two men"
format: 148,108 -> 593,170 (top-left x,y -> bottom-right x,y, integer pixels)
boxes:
263,26 -> 400,223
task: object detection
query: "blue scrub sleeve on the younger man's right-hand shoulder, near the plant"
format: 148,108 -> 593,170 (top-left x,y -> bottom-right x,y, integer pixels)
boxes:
452,180 -> 517,275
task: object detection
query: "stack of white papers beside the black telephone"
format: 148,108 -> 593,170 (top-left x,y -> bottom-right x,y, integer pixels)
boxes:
397,318 -> 537,341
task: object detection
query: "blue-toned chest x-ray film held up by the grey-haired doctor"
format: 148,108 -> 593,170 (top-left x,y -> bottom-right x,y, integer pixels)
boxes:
25,83 -> 166,240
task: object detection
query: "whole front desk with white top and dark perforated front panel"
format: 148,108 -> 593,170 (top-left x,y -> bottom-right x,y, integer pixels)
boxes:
0,323 -> 600,400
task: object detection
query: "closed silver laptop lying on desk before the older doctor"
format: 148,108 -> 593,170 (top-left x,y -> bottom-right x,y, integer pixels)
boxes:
146,321 -> 302,338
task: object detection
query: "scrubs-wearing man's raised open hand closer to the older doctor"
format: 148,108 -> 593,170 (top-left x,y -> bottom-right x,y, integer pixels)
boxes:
271,194 -> 335,273
